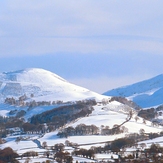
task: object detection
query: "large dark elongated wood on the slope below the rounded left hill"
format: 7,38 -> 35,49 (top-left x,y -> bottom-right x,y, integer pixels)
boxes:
31,103 -> 93,128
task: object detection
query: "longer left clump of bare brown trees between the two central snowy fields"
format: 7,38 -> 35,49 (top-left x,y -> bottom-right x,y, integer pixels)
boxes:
57,124 -> 99,137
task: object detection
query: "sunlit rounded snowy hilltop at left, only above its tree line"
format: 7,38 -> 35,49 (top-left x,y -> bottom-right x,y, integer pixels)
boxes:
0,68 -> 105,102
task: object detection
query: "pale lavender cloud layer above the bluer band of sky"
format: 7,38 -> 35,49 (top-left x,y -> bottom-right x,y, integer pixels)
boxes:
0,0 -> 163,57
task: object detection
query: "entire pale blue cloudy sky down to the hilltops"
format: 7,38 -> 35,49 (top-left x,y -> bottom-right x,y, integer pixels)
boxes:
0,0 -> 163,93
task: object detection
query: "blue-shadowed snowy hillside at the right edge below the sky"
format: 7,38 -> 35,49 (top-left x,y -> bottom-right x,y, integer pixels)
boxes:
103,74 -> 163,108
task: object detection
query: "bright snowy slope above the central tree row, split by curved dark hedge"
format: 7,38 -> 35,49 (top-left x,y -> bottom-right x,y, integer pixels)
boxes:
70,102 -> 163,133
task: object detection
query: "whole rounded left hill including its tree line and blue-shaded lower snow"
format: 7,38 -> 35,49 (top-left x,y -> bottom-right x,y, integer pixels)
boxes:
0,68 -> 110,120
